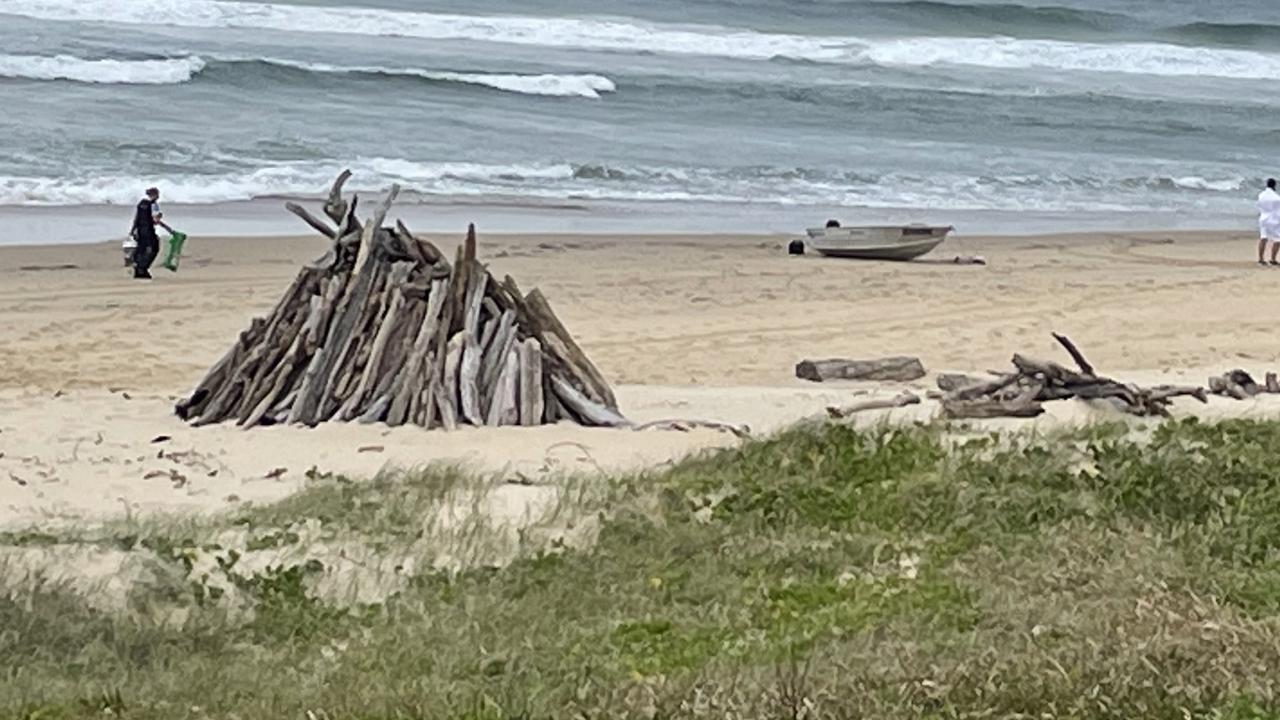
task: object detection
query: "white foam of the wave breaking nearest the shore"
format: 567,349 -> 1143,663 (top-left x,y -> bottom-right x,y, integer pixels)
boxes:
0,158 -> 1249,211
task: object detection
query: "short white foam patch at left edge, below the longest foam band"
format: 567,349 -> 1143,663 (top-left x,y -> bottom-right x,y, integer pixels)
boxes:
0,54 -> 205,85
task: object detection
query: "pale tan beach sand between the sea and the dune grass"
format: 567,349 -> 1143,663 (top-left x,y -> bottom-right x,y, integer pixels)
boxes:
0,233 -> 1280,527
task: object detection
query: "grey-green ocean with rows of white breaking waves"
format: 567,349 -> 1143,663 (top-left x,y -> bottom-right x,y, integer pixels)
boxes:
0,0 -> 1280,241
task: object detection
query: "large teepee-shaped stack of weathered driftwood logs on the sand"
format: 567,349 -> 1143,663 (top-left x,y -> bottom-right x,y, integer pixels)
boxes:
177,172 -> 627,429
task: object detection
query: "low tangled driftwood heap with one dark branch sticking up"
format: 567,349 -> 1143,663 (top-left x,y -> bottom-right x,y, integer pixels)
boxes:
938,334 -> 1208,419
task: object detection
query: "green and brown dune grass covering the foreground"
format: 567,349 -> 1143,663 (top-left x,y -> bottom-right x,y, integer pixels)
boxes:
0,421 -> 1280,720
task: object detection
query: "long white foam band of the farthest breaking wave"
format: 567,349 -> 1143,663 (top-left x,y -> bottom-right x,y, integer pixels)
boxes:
10,0 -> 1280,79
